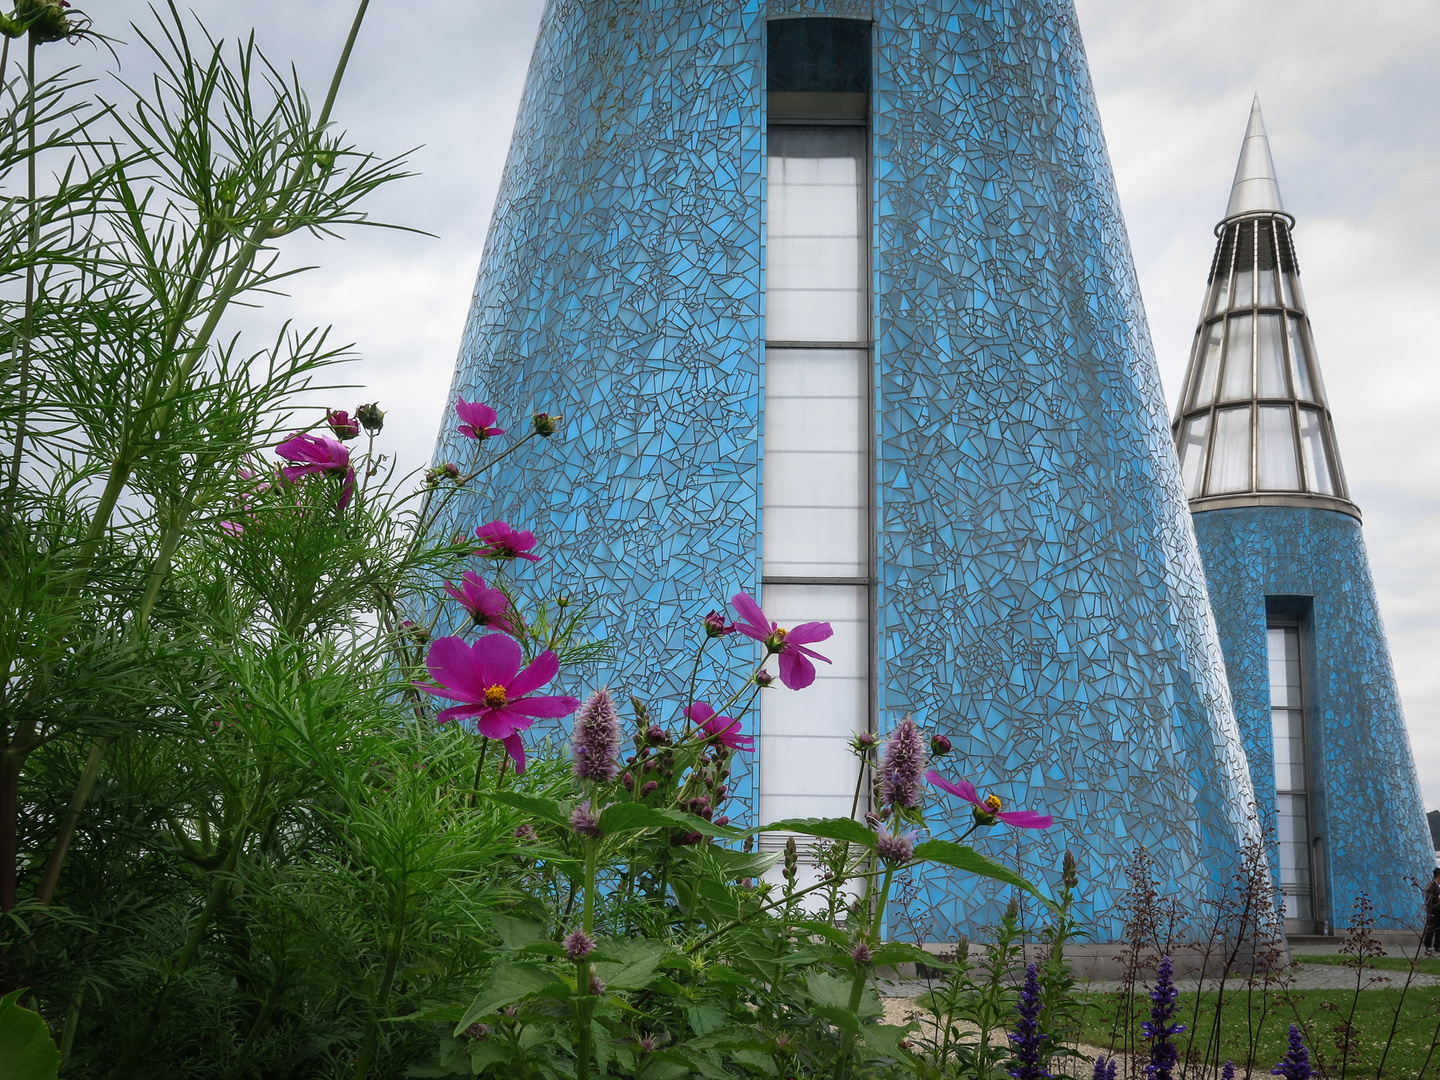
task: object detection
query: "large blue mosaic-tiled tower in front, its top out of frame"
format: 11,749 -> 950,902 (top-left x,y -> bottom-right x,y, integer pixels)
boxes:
436,0 -> 1251,942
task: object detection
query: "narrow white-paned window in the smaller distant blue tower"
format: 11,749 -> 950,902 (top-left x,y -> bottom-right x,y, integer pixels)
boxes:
1266,621 -> 1315,932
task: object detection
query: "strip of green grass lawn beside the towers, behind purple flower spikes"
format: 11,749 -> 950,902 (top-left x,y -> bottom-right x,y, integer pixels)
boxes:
1081,988 -> 1440,1080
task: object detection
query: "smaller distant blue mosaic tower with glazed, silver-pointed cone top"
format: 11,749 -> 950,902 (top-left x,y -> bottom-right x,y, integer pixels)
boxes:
1175,99 -> 1434,933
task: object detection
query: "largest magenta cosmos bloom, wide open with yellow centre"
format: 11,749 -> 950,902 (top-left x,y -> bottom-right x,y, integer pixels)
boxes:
415,634 -> 580,773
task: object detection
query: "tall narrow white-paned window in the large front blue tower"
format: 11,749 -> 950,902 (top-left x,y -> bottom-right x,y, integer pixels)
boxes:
759,19 -> 873,845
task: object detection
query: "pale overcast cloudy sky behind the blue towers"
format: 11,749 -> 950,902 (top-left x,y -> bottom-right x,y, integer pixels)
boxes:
87,0 -> 1440,808
